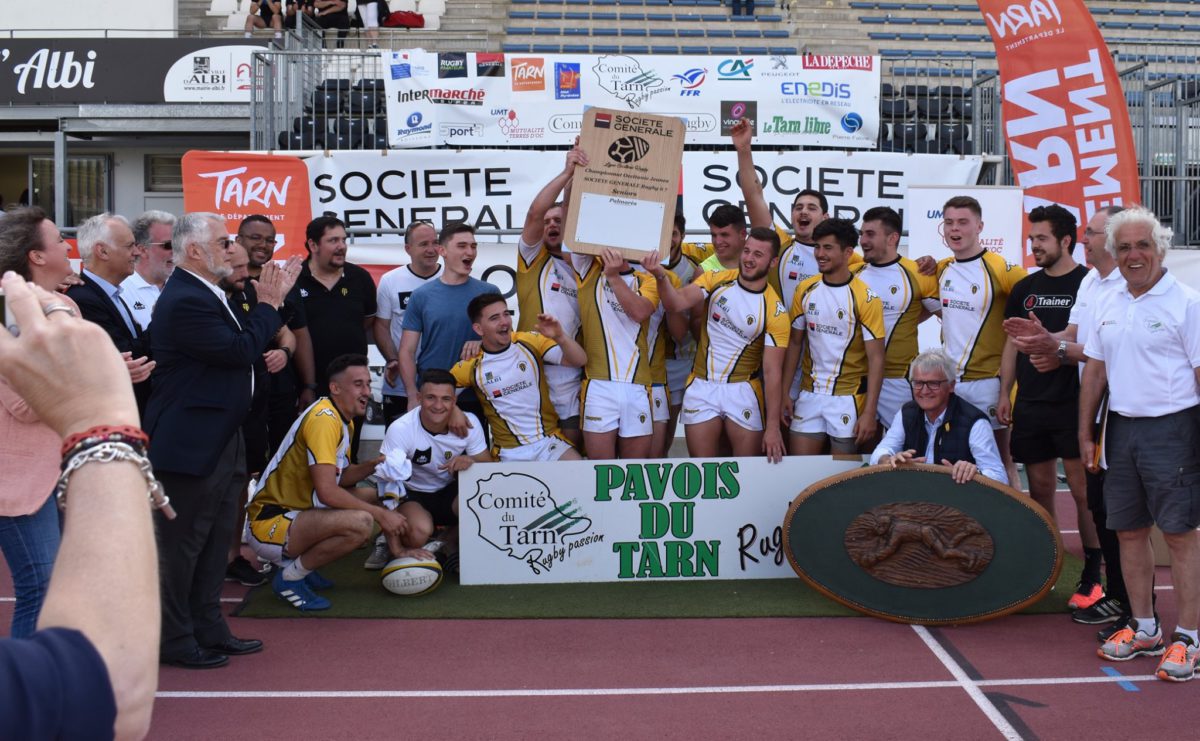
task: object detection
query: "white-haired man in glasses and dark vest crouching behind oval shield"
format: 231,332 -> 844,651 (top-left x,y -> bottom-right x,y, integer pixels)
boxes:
871,350 -> 1008,484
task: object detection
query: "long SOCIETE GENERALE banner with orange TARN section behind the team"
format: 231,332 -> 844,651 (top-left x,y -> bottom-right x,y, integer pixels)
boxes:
184,150 -> 984,265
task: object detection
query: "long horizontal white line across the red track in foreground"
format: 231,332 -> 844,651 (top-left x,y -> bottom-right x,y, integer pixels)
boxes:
156,671 -> 1158,700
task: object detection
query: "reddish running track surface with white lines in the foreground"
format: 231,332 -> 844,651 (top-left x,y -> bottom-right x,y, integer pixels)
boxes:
0,493 -> 1200,741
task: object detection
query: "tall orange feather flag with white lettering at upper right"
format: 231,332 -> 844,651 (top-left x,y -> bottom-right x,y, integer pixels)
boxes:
979,0 -> 1141,266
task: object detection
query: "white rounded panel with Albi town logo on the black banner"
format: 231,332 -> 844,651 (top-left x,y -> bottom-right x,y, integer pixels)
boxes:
162,46 -> 263,103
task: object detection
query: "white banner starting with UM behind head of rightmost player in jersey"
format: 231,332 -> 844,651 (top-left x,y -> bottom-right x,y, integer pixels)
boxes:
905,185 -> 1022,350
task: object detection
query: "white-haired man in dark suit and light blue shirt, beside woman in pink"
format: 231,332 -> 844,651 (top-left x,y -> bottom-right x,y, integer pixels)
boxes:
67,213 -> 154,415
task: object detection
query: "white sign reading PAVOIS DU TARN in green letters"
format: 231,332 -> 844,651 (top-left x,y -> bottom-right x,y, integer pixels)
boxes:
458,456 -> 862,584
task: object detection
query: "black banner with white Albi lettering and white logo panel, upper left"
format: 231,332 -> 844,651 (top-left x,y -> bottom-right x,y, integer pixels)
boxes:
0,38 -> 265,106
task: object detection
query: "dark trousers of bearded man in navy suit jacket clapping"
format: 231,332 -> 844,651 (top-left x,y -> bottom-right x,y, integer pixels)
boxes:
156,430 -> 246,659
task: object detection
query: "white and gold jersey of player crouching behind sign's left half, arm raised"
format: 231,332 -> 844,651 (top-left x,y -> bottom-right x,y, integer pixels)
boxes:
450,332 -> 563,448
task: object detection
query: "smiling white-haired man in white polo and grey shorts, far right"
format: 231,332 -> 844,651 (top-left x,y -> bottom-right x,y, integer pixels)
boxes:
1079,207 -> 1200,682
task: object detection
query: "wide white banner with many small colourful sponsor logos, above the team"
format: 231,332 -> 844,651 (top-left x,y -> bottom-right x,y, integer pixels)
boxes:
382,50 -> 880,149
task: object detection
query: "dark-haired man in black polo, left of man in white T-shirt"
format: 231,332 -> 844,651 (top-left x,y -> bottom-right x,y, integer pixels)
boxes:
296,216 -> 376,460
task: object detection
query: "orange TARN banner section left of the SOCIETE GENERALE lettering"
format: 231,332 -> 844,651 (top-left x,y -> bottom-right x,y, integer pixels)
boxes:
182,150 -> 312,260
